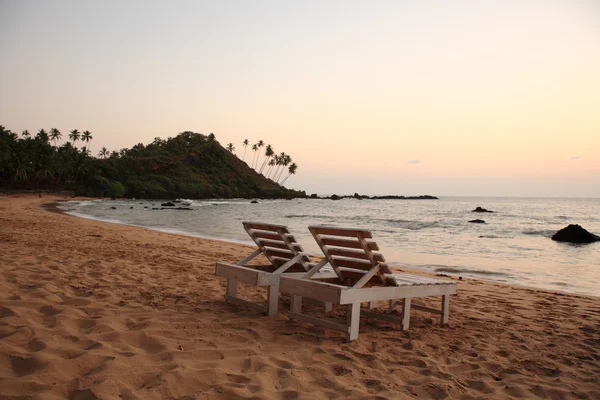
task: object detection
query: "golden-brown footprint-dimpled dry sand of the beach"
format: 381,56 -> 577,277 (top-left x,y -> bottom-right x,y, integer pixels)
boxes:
0,195 -> 600,399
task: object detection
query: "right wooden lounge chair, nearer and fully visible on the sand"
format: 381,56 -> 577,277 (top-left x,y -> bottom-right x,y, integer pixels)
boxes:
280,226 -> 456,340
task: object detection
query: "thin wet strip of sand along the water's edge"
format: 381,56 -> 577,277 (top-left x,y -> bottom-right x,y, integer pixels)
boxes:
48,197 -> 600,300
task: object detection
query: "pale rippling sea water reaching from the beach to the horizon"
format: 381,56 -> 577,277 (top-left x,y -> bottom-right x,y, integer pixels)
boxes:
59,197 -> 600,296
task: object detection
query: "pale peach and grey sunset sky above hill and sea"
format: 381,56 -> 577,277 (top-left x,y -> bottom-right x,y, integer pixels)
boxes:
0,0 -> 600,198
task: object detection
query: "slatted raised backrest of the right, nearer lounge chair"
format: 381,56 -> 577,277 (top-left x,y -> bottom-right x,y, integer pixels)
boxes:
308,226 -> 391,287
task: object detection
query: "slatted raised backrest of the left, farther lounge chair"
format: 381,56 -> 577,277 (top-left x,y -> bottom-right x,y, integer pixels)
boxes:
242,222 -> 310,271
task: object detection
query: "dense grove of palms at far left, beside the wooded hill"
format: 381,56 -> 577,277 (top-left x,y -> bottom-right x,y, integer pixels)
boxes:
0,126 -> 92,188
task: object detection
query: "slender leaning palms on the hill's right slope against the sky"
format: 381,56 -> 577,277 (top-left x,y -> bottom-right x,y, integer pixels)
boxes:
237,139 -> 298,185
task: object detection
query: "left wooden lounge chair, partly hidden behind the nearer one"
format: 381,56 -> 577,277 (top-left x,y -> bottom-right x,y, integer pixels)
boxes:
215,222 -> 331,316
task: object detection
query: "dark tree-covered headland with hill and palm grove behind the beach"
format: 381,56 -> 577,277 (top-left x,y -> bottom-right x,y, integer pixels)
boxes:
0,126 -> 306,199
